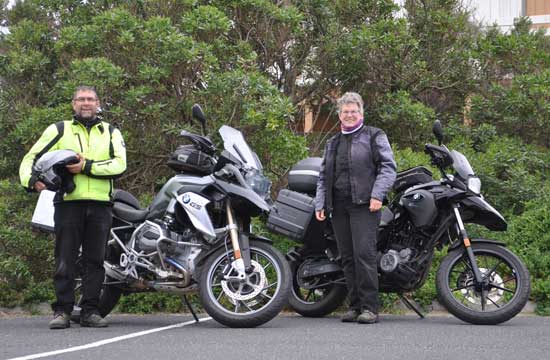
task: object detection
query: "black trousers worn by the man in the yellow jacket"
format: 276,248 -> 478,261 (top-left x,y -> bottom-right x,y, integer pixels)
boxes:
52,201 -> 113,313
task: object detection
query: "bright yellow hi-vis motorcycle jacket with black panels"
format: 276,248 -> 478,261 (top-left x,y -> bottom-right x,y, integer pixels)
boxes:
19,120 -> 126,201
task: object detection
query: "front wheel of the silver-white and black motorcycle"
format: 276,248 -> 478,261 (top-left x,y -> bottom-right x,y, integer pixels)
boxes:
199,241 -> 290,327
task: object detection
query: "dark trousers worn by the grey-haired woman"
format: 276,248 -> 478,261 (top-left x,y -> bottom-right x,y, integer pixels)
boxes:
332,199 -> 380,313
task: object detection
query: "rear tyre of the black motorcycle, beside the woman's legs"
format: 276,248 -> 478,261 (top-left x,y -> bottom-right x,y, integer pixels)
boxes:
288,261 -> 348,317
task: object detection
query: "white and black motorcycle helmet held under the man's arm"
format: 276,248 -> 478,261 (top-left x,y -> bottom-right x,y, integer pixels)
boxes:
33,150 -> 79,193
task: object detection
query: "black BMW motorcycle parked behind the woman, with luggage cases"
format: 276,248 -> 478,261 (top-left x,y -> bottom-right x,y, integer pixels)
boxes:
268,122 -> 530,324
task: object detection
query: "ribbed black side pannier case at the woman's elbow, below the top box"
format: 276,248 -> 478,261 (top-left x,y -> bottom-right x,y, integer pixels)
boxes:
267,189 -> 315,241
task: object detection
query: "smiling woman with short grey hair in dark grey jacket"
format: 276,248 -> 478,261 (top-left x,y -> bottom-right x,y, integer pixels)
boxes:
315,92 -> 396,324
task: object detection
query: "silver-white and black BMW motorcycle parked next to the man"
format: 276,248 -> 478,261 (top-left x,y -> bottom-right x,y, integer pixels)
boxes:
66,105 -> 291,327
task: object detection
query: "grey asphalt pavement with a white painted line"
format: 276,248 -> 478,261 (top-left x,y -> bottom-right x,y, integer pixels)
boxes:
0,315 -> 550,360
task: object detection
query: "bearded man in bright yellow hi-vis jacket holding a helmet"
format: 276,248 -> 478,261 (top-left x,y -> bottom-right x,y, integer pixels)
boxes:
19,86 -> 126,329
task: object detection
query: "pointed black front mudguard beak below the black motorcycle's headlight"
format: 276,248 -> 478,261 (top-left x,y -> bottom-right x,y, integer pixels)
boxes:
461,196 -> 508,231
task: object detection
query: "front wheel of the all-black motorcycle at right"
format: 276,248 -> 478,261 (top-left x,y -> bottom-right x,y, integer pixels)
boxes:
436,243 -> 531,325
